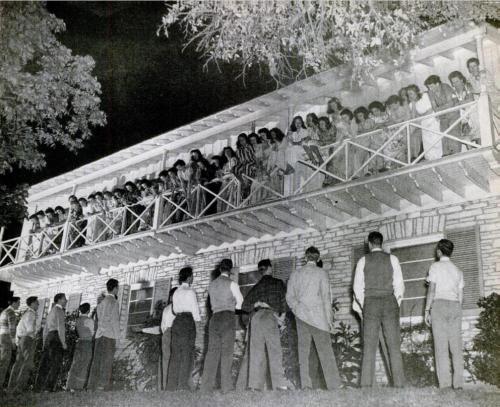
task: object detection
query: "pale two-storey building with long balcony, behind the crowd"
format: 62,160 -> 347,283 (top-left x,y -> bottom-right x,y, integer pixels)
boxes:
0,25 -> 500,386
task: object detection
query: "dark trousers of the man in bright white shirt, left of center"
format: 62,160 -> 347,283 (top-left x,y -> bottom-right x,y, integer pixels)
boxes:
167,313 -> 196,390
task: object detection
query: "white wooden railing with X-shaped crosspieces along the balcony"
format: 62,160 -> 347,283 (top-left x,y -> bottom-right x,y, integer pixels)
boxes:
0,101 -> 491,267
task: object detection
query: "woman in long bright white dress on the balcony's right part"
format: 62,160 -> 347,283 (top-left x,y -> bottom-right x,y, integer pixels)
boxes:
406,85 -> 443,160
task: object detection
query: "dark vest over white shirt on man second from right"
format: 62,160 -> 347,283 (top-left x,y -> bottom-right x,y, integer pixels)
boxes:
364,251 -> 394,297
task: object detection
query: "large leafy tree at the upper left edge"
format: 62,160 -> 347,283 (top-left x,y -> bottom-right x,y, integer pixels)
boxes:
0,2 -> 106,225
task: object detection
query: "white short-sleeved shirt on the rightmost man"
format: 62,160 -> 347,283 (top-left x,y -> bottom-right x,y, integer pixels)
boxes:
427,256 -> 464,301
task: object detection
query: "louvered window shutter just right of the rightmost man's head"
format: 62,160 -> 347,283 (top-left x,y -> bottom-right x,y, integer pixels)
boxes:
446,227 -> 481,309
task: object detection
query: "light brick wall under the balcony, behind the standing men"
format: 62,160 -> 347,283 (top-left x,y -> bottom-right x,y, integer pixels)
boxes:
12,196 -> 500,386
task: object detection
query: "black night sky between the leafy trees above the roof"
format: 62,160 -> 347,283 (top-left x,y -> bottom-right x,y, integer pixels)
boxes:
15,2 -> 275,184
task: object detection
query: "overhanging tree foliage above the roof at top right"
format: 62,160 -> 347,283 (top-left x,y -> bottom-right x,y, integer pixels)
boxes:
158,0 -> 498,84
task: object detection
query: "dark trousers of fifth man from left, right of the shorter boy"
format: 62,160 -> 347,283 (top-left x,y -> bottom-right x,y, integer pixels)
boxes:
87,336 -> 116,390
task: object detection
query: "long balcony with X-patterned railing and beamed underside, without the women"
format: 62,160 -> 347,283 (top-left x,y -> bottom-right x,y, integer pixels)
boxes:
0,95 -> 500,284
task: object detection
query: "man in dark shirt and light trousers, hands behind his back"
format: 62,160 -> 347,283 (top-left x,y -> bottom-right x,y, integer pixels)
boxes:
241,259 -> 287,390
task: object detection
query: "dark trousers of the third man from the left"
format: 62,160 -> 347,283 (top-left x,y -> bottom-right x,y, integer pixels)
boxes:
35,331 -> 64,391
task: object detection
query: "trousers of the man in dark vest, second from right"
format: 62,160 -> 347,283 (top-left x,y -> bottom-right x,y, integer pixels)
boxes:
361,294 -> 405,387
